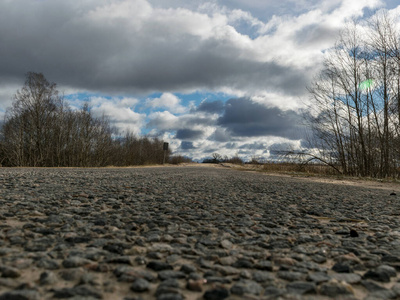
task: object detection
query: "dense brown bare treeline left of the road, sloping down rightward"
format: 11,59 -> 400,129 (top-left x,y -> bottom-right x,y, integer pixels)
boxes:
0,72 -> 170,167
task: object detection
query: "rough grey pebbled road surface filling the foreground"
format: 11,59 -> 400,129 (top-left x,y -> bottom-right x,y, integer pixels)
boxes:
0,167 -> 400,300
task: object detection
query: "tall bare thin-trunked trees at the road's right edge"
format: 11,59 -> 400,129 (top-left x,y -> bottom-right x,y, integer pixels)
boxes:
302,12 -> 400,178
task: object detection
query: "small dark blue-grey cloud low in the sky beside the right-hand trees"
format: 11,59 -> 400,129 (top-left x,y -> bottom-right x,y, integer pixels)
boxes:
218,98 -> 302,139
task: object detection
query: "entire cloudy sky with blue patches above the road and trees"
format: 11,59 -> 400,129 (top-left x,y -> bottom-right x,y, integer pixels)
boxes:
0,0 -> 400,159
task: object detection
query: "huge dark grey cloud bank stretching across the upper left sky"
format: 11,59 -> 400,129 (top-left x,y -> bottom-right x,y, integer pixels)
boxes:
0,0 -> 308,94
